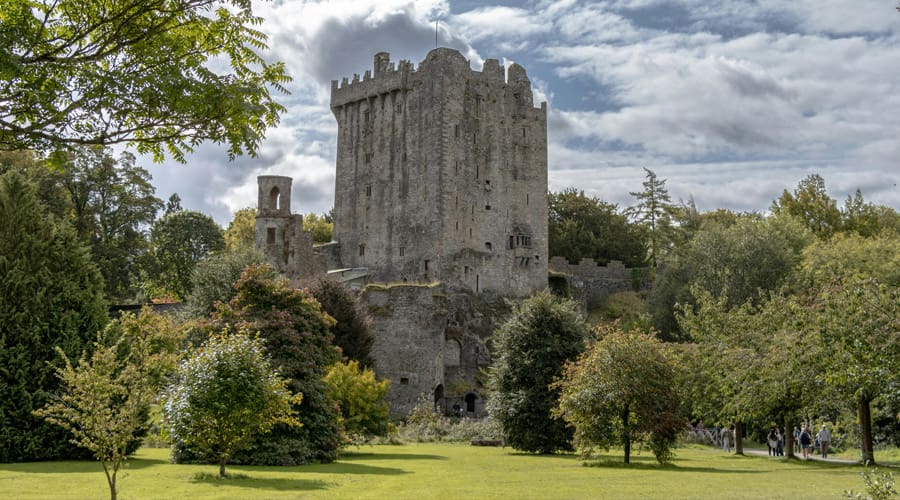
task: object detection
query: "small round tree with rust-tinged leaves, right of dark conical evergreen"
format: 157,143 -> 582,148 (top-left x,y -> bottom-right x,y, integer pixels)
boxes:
552,326 -> 688,464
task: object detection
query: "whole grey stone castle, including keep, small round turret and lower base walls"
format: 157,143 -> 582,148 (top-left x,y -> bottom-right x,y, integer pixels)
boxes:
256,48 -> 549,415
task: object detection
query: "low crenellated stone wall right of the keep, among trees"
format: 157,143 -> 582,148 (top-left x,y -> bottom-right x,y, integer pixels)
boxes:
549,257 -> 650,310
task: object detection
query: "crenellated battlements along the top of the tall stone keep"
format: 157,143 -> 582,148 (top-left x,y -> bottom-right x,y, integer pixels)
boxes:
331,47 -> 546,109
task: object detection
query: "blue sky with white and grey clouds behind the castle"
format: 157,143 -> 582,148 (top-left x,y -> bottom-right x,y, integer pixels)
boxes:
142,0 -> 900,226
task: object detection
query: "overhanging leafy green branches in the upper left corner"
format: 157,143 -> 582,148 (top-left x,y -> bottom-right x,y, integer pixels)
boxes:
0,0 -> 290,161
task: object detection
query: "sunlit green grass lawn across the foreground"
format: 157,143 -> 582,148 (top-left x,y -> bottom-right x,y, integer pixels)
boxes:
0,444 -> 884,500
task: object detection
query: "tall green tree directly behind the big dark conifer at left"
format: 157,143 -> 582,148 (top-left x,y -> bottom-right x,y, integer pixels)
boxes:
58,147 -> 162,300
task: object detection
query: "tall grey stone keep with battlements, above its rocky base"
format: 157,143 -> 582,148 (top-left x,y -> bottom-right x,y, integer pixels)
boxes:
332,48 -> 548,296
